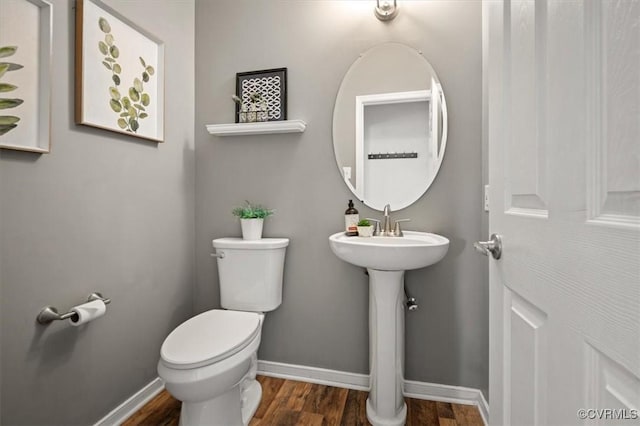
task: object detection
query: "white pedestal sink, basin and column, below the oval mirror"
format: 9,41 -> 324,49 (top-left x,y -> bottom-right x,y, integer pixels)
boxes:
329,231 -> 449,426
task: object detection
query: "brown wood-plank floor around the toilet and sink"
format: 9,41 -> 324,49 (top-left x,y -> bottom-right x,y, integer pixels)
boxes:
123,376 -> 484,426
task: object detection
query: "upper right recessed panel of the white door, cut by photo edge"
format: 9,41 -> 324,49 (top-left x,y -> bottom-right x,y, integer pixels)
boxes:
585,1 -> 640,226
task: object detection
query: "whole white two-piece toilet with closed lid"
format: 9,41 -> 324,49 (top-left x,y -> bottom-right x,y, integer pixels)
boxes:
158,238 -> 289,426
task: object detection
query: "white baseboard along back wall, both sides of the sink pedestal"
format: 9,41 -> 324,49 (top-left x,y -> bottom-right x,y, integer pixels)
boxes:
258,360 -> 489,425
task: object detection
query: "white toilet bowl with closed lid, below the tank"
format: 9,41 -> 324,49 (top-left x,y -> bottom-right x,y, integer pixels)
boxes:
158,309 -> 264,426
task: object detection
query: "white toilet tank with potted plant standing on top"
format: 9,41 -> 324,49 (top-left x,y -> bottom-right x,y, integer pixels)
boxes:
213,238 -> 289,312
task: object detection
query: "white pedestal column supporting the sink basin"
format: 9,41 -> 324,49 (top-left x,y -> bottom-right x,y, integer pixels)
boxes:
367,268 -> 407,426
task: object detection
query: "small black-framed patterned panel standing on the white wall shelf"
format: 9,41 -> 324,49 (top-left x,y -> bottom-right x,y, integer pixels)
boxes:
236,68 -> 287,123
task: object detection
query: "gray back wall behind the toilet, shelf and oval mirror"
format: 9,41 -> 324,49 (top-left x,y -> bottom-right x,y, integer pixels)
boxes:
195,0 -> 488,395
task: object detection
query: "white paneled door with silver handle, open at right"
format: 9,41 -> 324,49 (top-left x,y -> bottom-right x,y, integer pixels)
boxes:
483,0 -> 640,426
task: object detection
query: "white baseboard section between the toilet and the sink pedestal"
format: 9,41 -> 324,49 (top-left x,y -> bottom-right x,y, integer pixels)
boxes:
258,360 -> 369,391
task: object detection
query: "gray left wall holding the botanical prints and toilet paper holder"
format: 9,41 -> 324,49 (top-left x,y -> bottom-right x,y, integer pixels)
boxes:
0,0 -> 195,425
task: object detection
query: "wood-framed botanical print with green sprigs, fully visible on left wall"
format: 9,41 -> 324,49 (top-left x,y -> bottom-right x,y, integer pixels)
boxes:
75,0 -> 164,142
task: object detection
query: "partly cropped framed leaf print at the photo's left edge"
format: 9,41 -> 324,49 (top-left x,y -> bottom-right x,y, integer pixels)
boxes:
0,0 -> 53,153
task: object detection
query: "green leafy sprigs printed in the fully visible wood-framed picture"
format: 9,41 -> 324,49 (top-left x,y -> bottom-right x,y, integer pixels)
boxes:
98,17 -> 155,133
